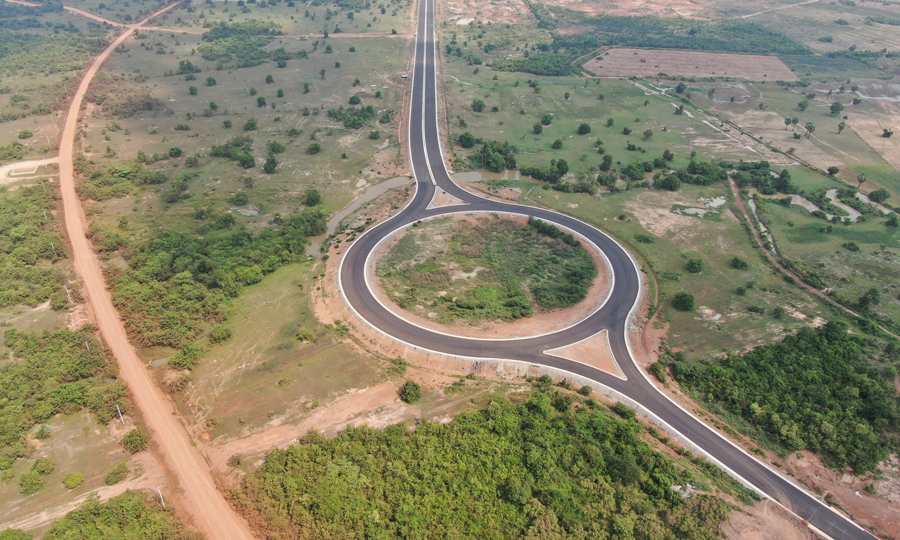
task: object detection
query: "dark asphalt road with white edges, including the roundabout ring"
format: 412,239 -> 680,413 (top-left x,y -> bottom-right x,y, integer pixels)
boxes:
338,0 -> 875,540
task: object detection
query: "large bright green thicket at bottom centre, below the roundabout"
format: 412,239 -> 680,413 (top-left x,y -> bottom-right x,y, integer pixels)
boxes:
235,390 -> 726,540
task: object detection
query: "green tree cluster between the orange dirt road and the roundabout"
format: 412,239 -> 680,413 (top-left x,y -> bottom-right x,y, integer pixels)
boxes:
112,207 -> 326,348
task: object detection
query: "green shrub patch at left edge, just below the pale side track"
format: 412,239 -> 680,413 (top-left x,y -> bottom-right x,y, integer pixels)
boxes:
0,185 -> 72,309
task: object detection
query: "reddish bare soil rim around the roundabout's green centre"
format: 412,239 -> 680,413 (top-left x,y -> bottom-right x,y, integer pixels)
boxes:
369,216 -> 610,339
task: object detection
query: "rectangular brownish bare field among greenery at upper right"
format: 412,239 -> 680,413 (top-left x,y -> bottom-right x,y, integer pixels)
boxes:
584,49 -> 800,81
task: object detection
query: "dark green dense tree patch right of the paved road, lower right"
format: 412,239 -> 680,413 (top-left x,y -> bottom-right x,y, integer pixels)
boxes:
673,322 -> 900,471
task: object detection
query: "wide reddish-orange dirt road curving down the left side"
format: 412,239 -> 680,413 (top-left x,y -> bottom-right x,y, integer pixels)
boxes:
59,4 -> 253,540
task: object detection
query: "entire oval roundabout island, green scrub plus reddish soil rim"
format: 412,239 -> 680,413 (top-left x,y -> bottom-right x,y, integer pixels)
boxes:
370,214 -> 609,339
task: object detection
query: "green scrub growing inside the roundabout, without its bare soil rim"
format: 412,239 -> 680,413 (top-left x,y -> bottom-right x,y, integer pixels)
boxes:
378,219 -> 597,322
